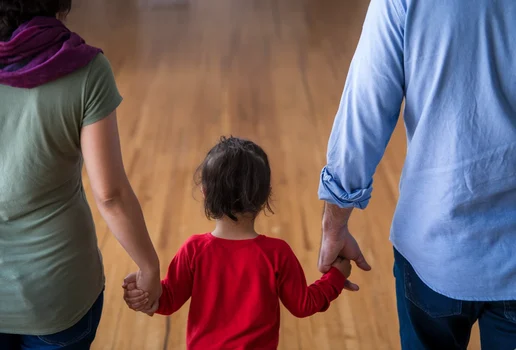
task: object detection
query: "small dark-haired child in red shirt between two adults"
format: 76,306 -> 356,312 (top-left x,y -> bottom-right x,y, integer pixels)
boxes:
124,137 -> 351,350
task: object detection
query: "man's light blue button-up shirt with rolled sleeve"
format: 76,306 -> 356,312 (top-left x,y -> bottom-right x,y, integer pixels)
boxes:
319,0 -> 516,301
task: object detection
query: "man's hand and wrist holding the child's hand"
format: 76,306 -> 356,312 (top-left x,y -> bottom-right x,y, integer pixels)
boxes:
319,204 -> 371,291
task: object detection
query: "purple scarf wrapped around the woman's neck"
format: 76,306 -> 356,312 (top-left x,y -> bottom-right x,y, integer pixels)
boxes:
0,17 -> 102,89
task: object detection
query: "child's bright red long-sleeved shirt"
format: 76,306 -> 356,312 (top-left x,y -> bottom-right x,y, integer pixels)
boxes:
157,233 -> 346,350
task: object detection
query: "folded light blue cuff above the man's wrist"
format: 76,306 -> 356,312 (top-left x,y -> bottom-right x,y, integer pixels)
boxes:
319,166 -> 373,209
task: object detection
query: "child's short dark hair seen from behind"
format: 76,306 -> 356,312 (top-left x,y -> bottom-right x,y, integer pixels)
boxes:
196,137 -> 273,221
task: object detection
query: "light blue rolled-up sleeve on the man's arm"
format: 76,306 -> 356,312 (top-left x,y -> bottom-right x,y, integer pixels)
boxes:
319,0 -> 405,209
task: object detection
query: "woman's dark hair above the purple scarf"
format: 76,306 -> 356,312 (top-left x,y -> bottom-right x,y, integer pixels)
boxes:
0,0 -> 72,41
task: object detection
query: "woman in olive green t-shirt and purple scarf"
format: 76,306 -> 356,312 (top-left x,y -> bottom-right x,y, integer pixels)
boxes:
0,0 -> 161,350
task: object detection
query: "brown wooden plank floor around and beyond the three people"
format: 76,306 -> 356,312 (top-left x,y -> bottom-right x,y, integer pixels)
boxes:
69,0 -> 478,350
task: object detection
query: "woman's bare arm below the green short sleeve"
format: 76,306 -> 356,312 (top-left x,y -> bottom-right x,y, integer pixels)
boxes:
81,111 -> 161,304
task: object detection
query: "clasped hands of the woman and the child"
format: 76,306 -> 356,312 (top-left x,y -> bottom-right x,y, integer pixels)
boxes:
122,270 -> 162,317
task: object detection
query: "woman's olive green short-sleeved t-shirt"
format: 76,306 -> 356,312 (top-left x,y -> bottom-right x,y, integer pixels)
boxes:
0,54 -> 122,335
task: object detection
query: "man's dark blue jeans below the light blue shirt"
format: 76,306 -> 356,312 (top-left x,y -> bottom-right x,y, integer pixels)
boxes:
394,250 -> 516,350
